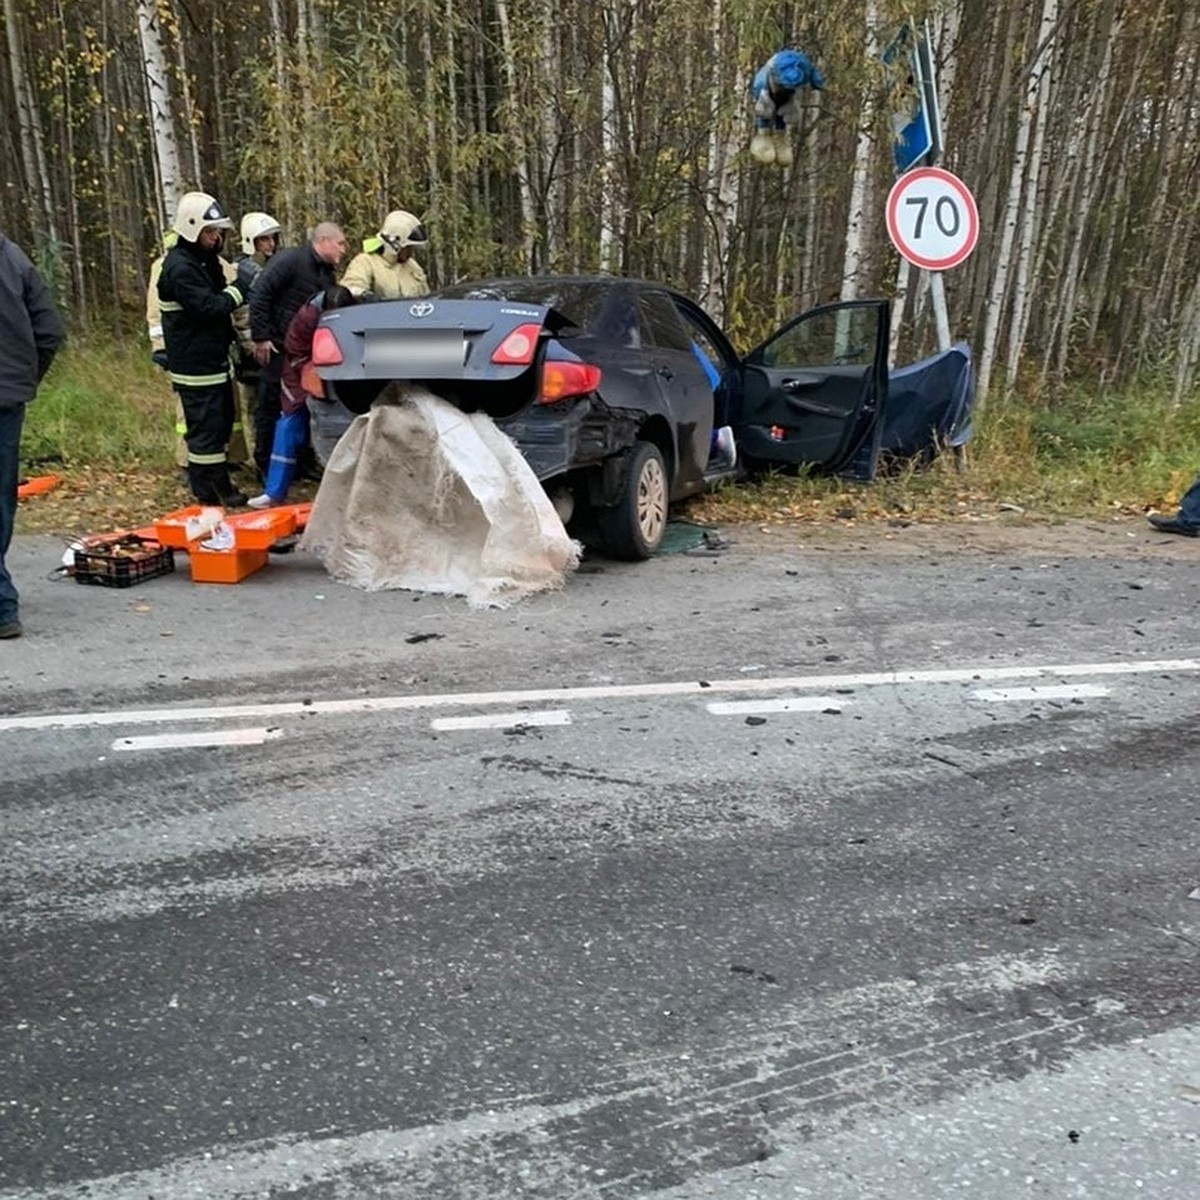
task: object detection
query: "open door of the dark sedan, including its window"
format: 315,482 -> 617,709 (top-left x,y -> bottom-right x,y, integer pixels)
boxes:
731,300 -> 890,470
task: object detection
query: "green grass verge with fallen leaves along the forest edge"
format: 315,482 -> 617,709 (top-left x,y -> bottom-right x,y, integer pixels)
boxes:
23,340 -> 1200,521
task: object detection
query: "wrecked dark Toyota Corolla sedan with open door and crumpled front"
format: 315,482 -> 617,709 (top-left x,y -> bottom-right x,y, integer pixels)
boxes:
313,276 -> 972,559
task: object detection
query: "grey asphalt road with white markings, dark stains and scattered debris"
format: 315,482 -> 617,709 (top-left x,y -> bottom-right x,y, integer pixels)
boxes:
0,539 -> 1200,1200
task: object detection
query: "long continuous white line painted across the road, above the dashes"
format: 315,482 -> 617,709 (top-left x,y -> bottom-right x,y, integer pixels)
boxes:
0,659 -> 1200,733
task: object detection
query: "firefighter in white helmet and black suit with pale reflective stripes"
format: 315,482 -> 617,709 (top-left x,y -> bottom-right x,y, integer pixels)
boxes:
158,192 -> 246,509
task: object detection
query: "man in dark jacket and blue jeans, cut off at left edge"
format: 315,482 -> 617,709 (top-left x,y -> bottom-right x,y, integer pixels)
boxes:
0,234 -> 64,638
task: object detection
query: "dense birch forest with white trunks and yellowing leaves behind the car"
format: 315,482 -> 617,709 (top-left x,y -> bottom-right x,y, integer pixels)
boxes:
0,0 -> 1200,403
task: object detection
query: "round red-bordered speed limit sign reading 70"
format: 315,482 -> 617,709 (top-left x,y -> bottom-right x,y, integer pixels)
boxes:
888,167 -> 979,271
